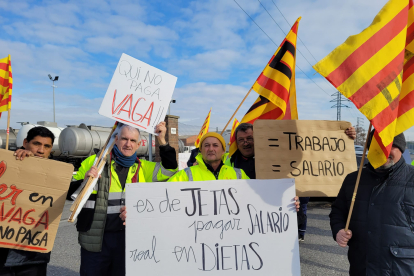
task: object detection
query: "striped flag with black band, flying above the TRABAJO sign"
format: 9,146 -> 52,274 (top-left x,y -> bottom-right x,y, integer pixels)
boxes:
241,17 -> 301,124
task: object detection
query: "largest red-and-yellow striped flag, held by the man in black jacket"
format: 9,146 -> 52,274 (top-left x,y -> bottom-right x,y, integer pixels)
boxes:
314,0 -> 414,168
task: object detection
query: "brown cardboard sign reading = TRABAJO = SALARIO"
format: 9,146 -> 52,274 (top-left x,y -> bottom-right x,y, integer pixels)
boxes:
254,120 -> 356,197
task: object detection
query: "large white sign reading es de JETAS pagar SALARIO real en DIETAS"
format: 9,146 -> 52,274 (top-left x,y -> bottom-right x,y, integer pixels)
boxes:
126,179 -> 300,276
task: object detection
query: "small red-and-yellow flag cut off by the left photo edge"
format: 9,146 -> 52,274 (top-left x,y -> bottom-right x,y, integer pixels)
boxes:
0,55 -> 13,117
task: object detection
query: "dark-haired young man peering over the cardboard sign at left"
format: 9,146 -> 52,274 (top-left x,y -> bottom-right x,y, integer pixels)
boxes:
0,127 -> 55,276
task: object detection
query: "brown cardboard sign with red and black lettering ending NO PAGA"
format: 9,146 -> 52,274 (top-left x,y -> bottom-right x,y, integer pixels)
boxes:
0,149 -> 73,253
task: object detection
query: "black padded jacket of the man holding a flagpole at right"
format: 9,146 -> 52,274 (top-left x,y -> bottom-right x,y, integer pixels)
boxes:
329,158 -> 414,276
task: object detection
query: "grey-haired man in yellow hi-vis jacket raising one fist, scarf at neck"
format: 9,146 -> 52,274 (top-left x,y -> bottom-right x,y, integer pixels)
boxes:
75,122 -> 178,276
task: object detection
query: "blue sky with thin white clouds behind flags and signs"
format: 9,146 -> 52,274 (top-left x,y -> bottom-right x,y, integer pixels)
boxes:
0,0 -> 414,140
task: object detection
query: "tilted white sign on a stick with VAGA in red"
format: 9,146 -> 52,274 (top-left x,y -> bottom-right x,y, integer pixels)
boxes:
99,54 -> 177,135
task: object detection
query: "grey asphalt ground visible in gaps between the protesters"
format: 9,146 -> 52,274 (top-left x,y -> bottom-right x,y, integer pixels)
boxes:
48,201 -> 348,276
